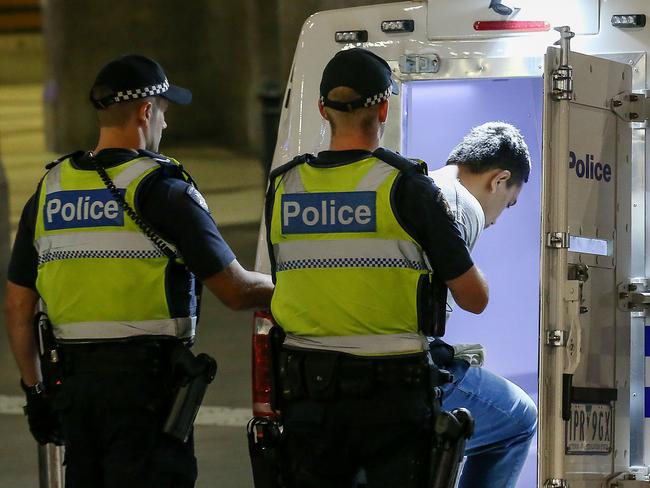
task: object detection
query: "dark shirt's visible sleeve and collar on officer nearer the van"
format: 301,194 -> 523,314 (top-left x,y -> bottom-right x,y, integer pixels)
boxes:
309,150 -> 474,281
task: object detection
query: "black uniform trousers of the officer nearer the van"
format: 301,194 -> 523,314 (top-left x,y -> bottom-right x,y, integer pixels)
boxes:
281,353 -> 432,488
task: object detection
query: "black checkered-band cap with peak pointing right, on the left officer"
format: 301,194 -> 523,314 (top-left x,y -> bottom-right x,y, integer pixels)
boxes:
90,54 -> 192,109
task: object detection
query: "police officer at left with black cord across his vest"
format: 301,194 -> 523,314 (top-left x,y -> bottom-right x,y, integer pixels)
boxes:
5,55 -> 273,488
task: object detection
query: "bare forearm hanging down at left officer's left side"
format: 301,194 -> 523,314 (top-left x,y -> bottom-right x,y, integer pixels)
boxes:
4,281 -> 42,386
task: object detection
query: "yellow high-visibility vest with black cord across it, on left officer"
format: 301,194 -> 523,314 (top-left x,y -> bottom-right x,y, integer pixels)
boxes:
34,157 -> 196,342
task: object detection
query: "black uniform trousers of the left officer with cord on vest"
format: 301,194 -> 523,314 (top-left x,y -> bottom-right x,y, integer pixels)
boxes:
55,344 -> 197,488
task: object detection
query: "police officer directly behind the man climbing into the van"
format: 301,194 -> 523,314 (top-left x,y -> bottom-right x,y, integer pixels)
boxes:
266,48 -> 488,488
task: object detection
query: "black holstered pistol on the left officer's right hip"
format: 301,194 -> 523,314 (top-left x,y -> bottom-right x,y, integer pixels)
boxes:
163,344 -> 217,442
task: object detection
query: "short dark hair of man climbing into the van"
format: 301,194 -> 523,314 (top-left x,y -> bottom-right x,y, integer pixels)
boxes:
447,122 -> 530,186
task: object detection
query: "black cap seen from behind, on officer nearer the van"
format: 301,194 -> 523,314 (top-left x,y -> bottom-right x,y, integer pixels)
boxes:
320,48 -> 398,112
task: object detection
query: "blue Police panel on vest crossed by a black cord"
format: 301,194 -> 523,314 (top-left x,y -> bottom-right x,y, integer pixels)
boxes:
43,190 -> 124,230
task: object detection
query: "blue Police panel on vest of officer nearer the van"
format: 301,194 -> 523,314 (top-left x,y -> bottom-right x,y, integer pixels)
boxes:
280,191 -> 377,234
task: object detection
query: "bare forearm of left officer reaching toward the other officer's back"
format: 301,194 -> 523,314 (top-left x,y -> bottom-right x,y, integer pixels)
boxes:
203,259 -> 274,310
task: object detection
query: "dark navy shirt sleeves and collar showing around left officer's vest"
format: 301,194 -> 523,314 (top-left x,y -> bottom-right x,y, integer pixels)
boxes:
8,149 -> 235,297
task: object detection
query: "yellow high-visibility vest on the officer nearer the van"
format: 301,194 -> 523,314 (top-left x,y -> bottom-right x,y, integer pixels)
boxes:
267,151 -> 430,355
